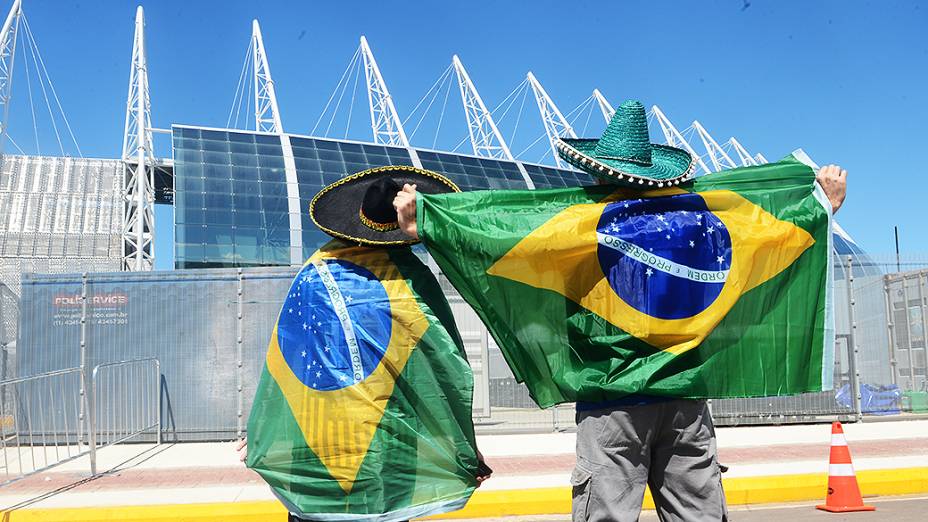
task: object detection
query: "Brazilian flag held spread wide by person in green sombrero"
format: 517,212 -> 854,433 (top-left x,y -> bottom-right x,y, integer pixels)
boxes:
417,157 -> 834,407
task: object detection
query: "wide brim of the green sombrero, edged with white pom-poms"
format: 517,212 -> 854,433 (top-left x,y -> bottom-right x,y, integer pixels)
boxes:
557,139 -> 696,187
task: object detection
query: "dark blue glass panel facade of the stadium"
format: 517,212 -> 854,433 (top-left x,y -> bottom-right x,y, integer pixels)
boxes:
173,125 -> 591,268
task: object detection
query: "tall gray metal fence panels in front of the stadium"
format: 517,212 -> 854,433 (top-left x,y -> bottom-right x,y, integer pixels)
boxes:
0,252 -> 928,443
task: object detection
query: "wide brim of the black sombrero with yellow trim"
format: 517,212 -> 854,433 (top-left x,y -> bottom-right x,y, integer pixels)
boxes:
309,165 -> 461,247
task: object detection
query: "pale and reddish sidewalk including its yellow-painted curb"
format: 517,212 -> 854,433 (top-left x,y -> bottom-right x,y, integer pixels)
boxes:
0,420 -> 928,522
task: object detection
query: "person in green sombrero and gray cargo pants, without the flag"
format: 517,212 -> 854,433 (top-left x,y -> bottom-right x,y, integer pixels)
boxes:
395,101 -> 846,522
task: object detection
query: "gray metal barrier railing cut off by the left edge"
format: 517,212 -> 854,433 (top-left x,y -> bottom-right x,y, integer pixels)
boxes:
0,368 -> 90,485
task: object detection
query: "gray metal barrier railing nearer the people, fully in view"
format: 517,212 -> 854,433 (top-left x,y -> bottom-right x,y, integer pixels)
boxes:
88,357 -> 161,475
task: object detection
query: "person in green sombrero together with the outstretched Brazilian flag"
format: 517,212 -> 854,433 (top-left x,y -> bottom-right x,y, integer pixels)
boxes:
394,101 -> 847,521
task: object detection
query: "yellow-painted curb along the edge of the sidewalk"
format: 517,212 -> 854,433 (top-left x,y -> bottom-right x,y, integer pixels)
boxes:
0,467 -> 928,522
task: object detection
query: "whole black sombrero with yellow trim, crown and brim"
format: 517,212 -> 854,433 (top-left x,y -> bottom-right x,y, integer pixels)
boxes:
309,166 -> 461,247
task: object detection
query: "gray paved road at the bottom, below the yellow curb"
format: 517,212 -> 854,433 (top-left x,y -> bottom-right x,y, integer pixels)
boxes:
461,496 -> 928,522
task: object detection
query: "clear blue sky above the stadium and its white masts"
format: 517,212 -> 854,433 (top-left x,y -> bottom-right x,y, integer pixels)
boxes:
0,0 -> 928,266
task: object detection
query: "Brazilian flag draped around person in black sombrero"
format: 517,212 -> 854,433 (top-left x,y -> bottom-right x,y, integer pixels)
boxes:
247,241 -> 477,522
